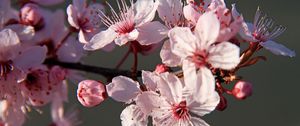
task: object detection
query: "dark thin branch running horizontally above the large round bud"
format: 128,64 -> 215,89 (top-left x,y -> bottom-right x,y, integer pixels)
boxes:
44,59 -> 142,77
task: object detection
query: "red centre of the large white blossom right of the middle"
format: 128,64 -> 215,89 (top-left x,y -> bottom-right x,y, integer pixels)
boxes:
192,50 -> 207,68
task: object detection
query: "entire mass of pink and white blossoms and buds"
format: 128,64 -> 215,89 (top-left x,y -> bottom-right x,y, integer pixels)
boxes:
0,0 -> 295,126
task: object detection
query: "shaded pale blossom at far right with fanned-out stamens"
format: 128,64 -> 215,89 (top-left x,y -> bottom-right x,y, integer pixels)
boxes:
232,5 -> 296,57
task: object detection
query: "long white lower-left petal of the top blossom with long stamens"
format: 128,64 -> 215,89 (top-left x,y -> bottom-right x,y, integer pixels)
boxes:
83,28 -> 117,50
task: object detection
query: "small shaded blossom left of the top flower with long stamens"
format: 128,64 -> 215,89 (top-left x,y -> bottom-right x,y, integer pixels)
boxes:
67,0 -> 104,43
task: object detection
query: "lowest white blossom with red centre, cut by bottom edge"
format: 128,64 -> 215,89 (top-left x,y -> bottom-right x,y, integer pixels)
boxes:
136,73 -> 219,126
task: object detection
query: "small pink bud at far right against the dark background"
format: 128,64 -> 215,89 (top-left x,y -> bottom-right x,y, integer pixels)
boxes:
232,81 -> 252,100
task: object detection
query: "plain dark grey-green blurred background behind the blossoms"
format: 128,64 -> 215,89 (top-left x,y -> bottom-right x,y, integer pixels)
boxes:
22,0 -> 300,126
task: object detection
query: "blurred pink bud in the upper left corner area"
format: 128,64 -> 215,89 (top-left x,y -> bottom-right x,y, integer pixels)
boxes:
20,3 -> 42,26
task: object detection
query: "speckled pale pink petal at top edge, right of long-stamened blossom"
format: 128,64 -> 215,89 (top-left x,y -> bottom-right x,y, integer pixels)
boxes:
157,0 -> 183,24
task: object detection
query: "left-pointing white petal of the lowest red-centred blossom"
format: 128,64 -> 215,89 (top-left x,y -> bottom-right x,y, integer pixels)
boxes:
136,91 -> 171,115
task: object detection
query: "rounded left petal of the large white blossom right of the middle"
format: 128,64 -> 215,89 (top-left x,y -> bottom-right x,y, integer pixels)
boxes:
169,27 -> 198,58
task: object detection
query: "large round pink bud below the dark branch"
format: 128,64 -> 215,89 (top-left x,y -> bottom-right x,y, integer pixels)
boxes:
77,80 -> 107,107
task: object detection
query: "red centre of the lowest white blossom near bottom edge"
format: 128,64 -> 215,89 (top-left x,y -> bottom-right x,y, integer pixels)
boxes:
172,101 -> 190,120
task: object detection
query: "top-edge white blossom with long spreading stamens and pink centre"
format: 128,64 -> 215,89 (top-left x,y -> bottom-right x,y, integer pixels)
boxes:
84,0 -> 166,50
